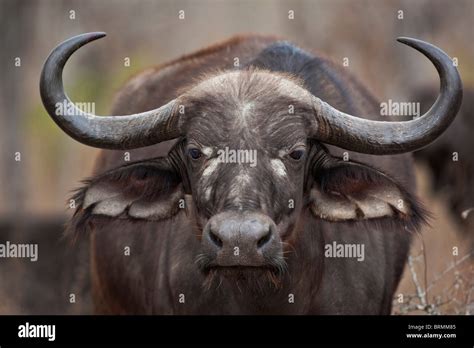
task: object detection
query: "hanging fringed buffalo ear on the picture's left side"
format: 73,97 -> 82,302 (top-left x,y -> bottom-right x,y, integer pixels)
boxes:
73,157 -> 184,220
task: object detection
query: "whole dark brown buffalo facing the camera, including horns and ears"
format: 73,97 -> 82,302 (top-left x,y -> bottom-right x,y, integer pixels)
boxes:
40,33 -> 462,314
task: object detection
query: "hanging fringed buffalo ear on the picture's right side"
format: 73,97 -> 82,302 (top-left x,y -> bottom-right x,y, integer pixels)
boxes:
310,160 -> 424,224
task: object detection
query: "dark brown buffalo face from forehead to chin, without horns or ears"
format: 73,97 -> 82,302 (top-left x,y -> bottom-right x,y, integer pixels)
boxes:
183,71 -> 311,273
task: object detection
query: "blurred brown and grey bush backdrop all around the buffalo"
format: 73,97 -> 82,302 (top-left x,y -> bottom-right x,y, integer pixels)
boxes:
0,0 -> 474,314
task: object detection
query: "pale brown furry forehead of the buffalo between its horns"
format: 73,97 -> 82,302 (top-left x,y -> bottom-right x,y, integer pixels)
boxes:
183,69 -> 312,147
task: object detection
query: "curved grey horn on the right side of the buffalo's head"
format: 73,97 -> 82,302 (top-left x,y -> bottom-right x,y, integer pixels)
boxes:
313,37 -> 462,155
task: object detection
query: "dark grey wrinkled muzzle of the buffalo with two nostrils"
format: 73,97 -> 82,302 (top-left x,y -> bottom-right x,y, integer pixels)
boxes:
201,211 -> 282,268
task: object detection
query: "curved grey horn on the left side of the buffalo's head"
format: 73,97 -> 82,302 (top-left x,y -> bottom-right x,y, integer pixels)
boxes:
40,32 -> 181,150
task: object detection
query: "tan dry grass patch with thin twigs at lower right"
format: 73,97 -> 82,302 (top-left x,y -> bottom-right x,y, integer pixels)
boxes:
393,164 -> 474,315
